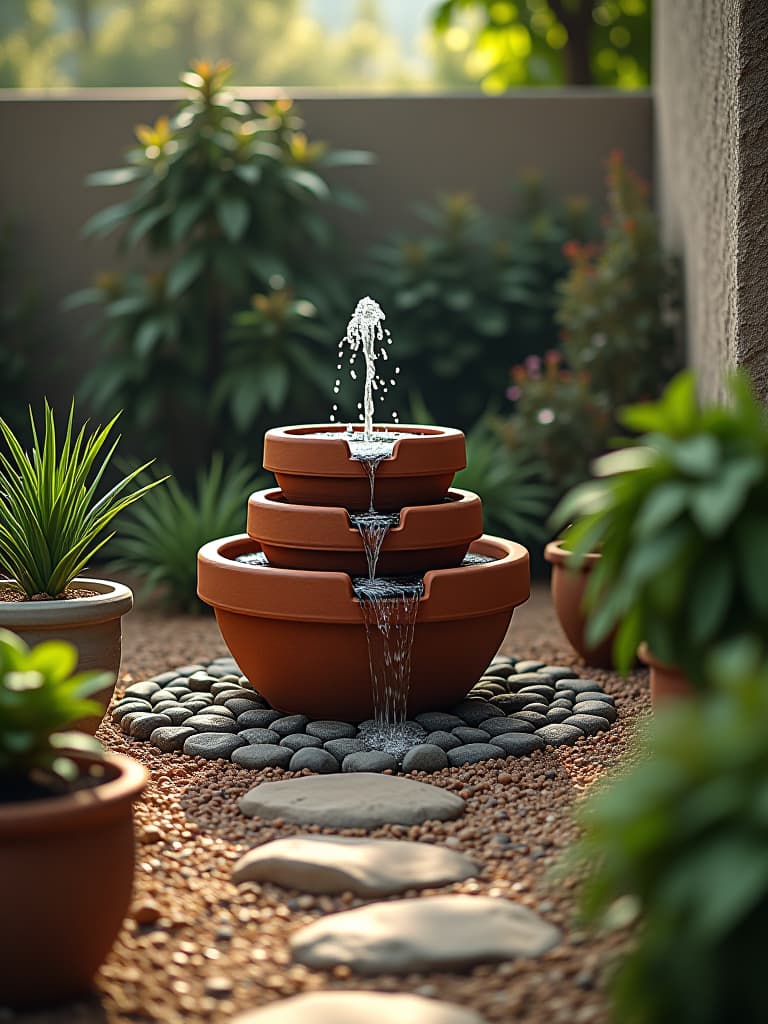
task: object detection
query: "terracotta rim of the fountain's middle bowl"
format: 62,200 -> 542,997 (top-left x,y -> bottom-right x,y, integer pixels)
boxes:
247,487 -> 482,553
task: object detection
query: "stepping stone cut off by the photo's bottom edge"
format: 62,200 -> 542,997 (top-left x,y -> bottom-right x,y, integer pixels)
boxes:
231,991 -> 483,1024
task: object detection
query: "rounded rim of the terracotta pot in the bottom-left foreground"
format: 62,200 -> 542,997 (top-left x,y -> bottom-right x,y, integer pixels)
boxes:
0,752 -> 150,842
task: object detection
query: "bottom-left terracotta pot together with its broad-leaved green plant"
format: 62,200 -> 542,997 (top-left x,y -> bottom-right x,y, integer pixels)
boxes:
0,630 -> 147,1006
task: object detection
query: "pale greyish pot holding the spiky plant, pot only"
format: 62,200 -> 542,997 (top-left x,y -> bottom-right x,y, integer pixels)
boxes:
0,577 -> 133,733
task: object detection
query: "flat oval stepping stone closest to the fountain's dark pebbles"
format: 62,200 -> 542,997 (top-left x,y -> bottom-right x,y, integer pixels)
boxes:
239,770 -> 464,828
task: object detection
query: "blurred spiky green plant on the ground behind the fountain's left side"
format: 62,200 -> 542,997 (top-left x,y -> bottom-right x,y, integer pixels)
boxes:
111,454 -> 265,612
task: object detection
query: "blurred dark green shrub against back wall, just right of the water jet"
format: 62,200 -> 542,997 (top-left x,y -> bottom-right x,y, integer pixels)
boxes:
371,172 -> 590,428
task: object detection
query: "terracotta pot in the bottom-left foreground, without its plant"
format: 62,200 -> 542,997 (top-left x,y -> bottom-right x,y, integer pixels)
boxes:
0,754 -> 148,1006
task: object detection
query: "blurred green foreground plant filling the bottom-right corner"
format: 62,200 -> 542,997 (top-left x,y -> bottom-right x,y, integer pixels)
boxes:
569,648 -> 768,1024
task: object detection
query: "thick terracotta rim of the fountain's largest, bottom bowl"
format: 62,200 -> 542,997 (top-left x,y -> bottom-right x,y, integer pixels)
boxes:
198,534 -> 530,625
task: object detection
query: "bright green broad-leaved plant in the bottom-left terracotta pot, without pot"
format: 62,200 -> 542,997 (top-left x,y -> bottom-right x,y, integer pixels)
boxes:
0,630 -> 112,799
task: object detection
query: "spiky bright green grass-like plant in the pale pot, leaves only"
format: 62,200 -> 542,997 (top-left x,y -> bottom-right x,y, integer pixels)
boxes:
0,401 -> 162,598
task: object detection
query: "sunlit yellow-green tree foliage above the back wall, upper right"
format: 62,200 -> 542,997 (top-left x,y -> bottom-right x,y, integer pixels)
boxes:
434,0 -> 651,93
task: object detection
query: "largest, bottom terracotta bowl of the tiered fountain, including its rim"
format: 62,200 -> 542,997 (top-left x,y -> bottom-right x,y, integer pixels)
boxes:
198,536 -> 530,722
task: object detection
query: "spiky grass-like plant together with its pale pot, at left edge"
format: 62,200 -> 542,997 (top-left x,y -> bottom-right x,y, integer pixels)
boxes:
0,401 -> 161,731
